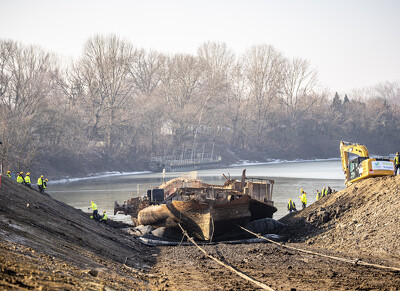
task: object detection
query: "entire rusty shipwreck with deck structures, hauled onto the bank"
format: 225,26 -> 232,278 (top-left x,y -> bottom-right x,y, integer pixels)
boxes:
114,170 -> 277,240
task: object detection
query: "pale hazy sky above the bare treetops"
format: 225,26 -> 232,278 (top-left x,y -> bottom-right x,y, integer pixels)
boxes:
0,0 -> 400,93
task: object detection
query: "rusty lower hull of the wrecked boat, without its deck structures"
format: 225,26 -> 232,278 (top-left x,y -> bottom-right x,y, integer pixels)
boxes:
138,195 -> 276,240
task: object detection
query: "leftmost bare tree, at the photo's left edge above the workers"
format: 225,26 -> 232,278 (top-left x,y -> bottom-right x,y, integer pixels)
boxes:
0,42 -> 57,169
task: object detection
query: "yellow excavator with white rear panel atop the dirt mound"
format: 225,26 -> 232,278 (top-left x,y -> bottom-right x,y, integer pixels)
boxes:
340,141 -> 394,187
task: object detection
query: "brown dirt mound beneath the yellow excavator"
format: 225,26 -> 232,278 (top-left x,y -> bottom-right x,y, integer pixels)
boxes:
281,175 -> 400,264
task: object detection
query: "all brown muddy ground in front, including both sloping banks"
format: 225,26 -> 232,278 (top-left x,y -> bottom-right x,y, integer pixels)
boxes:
0,176 -> 400,290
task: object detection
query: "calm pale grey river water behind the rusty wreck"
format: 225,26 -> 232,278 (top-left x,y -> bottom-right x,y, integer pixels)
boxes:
46,159 -> 345,223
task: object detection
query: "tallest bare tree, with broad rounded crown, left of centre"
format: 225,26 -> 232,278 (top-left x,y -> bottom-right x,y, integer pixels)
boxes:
74,35 -> 134,156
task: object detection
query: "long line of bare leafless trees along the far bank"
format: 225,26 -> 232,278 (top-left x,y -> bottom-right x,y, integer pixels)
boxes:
0,35 -> 400,176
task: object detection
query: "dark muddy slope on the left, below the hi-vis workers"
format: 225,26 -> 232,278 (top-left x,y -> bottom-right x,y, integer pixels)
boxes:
0,176 -> 154,289
